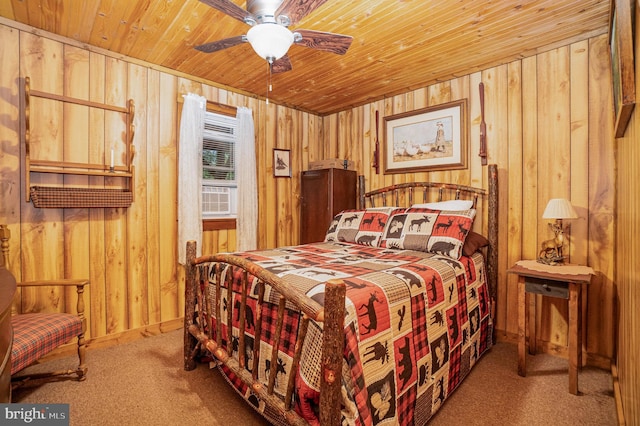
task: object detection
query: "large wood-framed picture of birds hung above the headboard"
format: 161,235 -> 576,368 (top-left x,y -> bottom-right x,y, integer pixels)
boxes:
383,99 -> 469,174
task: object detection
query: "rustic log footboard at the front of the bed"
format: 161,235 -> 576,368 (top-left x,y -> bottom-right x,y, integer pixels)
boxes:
184,241 -> 346,426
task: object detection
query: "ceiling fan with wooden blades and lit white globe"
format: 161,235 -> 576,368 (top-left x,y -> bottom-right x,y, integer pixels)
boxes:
195,0 -> 353,73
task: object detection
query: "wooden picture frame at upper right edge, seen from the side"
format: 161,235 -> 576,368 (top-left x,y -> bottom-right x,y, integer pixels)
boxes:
609,0 -> 636,138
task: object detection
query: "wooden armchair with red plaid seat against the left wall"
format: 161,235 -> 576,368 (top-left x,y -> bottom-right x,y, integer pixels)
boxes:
0,225 -> 89,389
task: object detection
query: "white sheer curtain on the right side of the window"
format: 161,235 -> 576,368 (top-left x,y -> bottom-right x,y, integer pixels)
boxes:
236,107 -> 258,251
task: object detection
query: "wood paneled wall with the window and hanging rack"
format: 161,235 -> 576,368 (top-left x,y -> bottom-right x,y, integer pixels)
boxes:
0,21 -> 320,339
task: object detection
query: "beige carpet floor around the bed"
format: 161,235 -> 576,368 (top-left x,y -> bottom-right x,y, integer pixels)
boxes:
13,330 -> 617,426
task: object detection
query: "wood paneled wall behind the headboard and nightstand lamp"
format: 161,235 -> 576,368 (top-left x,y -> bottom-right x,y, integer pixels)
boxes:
324,36 -> 615,368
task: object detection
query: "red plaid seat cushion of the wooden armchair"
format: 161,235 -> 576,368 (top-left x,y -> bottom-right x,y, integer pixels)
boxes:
11,313 -> 82,375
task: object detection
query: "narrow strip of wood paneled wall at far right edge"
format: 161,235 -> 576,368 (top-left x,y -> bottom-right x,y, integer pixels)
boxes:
614,6 -> 640,425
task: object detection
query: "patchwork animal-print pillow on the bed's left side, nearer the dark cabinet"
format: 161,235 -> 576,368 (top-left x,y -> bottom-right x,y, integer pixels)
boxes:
324,207 -> 396,246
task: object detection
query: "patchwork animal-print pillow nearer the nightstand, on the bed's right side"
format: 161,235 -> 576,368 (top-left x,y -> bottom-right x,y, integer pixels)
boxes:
379,208 -> 476,259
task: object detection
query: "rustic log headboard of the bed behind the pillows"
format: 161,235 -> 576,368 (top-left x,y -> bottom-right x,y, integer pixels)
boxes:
359,164 -> 498,314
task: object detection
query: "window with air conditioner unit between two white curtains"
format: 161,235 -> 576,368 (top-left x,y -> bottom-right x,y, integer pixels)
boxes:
202,111 -> 238,219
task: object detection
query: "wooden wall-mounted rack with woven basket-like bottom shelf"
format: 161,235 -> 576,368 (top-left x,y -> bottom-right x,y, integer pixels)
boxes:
22,77 -> 135,208
